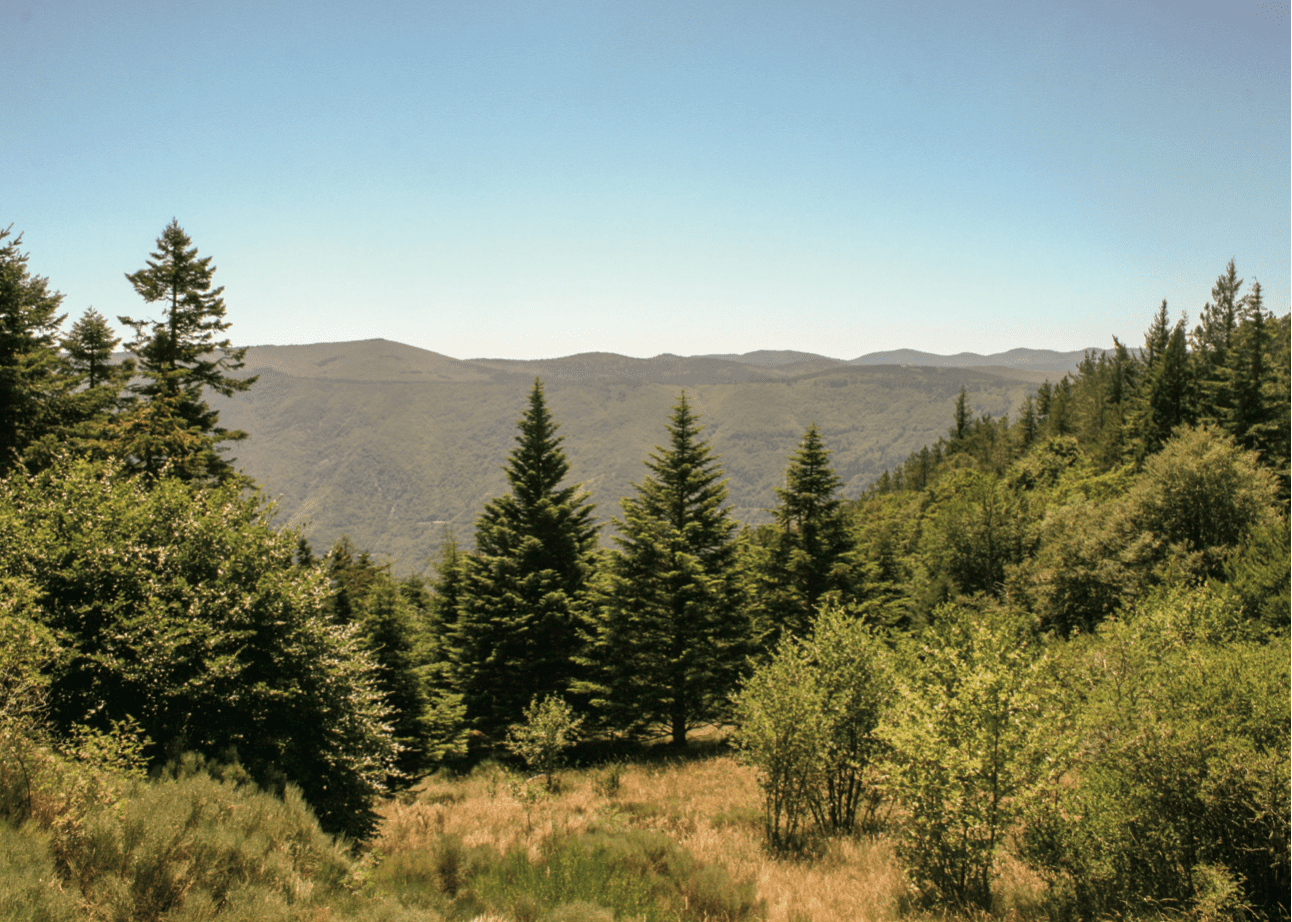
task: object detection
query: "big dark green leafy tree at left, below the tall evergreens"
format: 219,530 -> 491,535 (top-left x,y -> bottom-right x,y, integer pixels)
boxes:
0,458 -> 395,837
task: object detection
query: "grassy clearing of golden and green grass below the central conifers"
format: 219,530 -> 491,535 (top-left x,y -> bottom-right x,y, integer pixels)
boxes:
373,754 -> 1044,922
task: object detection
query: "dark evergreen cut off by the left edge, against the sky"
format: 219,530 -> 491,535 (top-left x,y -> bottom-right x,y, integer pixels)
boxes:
0,227 -> 71,475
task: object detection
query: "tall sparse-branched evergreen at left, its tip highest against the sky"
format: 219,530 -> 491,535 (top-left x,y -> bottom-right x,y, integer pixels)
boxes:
118,221 -> 256,480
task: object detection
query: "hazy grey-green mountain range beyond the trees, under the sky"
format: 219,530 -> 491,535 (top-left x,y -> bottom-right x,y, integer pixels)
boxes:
212,340 -> 1100,575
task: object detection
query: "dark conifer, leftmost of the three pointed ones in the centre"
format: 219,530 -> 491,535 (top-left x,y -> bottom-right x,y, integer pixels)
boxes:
456,380 -> 597,739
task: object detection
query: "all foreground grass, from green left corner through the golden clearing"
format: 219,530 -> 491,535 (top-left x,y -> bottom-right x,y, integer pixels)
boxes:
0,728 -> 1045,922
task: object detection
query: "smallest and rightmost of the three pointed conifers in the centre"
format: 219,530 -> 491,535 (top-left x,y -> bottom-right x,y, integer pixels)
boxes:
756,424 -> 852,647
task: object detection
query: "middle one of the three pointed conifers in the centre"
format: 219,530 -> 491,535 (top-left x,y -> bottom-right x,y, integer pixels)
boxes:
583,393 -> 751,745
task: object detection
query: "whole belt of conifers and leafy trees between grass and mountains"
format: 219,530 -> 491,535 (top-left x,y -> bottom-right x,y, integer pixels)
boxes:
0,222 -> 1289,917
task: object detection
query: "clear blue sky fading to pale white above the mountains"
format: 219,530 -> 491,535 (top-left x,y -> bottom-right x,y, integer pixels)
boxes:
0,0 -> 1292,359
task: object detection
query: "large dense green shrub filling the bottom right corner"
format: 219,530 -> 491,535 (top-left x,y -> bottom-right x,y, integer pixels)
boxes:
1023,589 -> 1292,919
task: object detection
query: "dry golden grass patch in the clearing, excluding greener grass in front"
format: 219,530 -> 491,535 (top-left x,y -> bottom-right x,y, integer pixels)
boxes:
376,755 -> 971,922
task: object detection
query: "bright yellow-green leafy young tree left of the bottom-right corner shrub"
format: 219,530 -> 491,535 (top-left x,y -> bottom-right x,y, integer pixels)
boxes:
879,606 -> 1048,909
